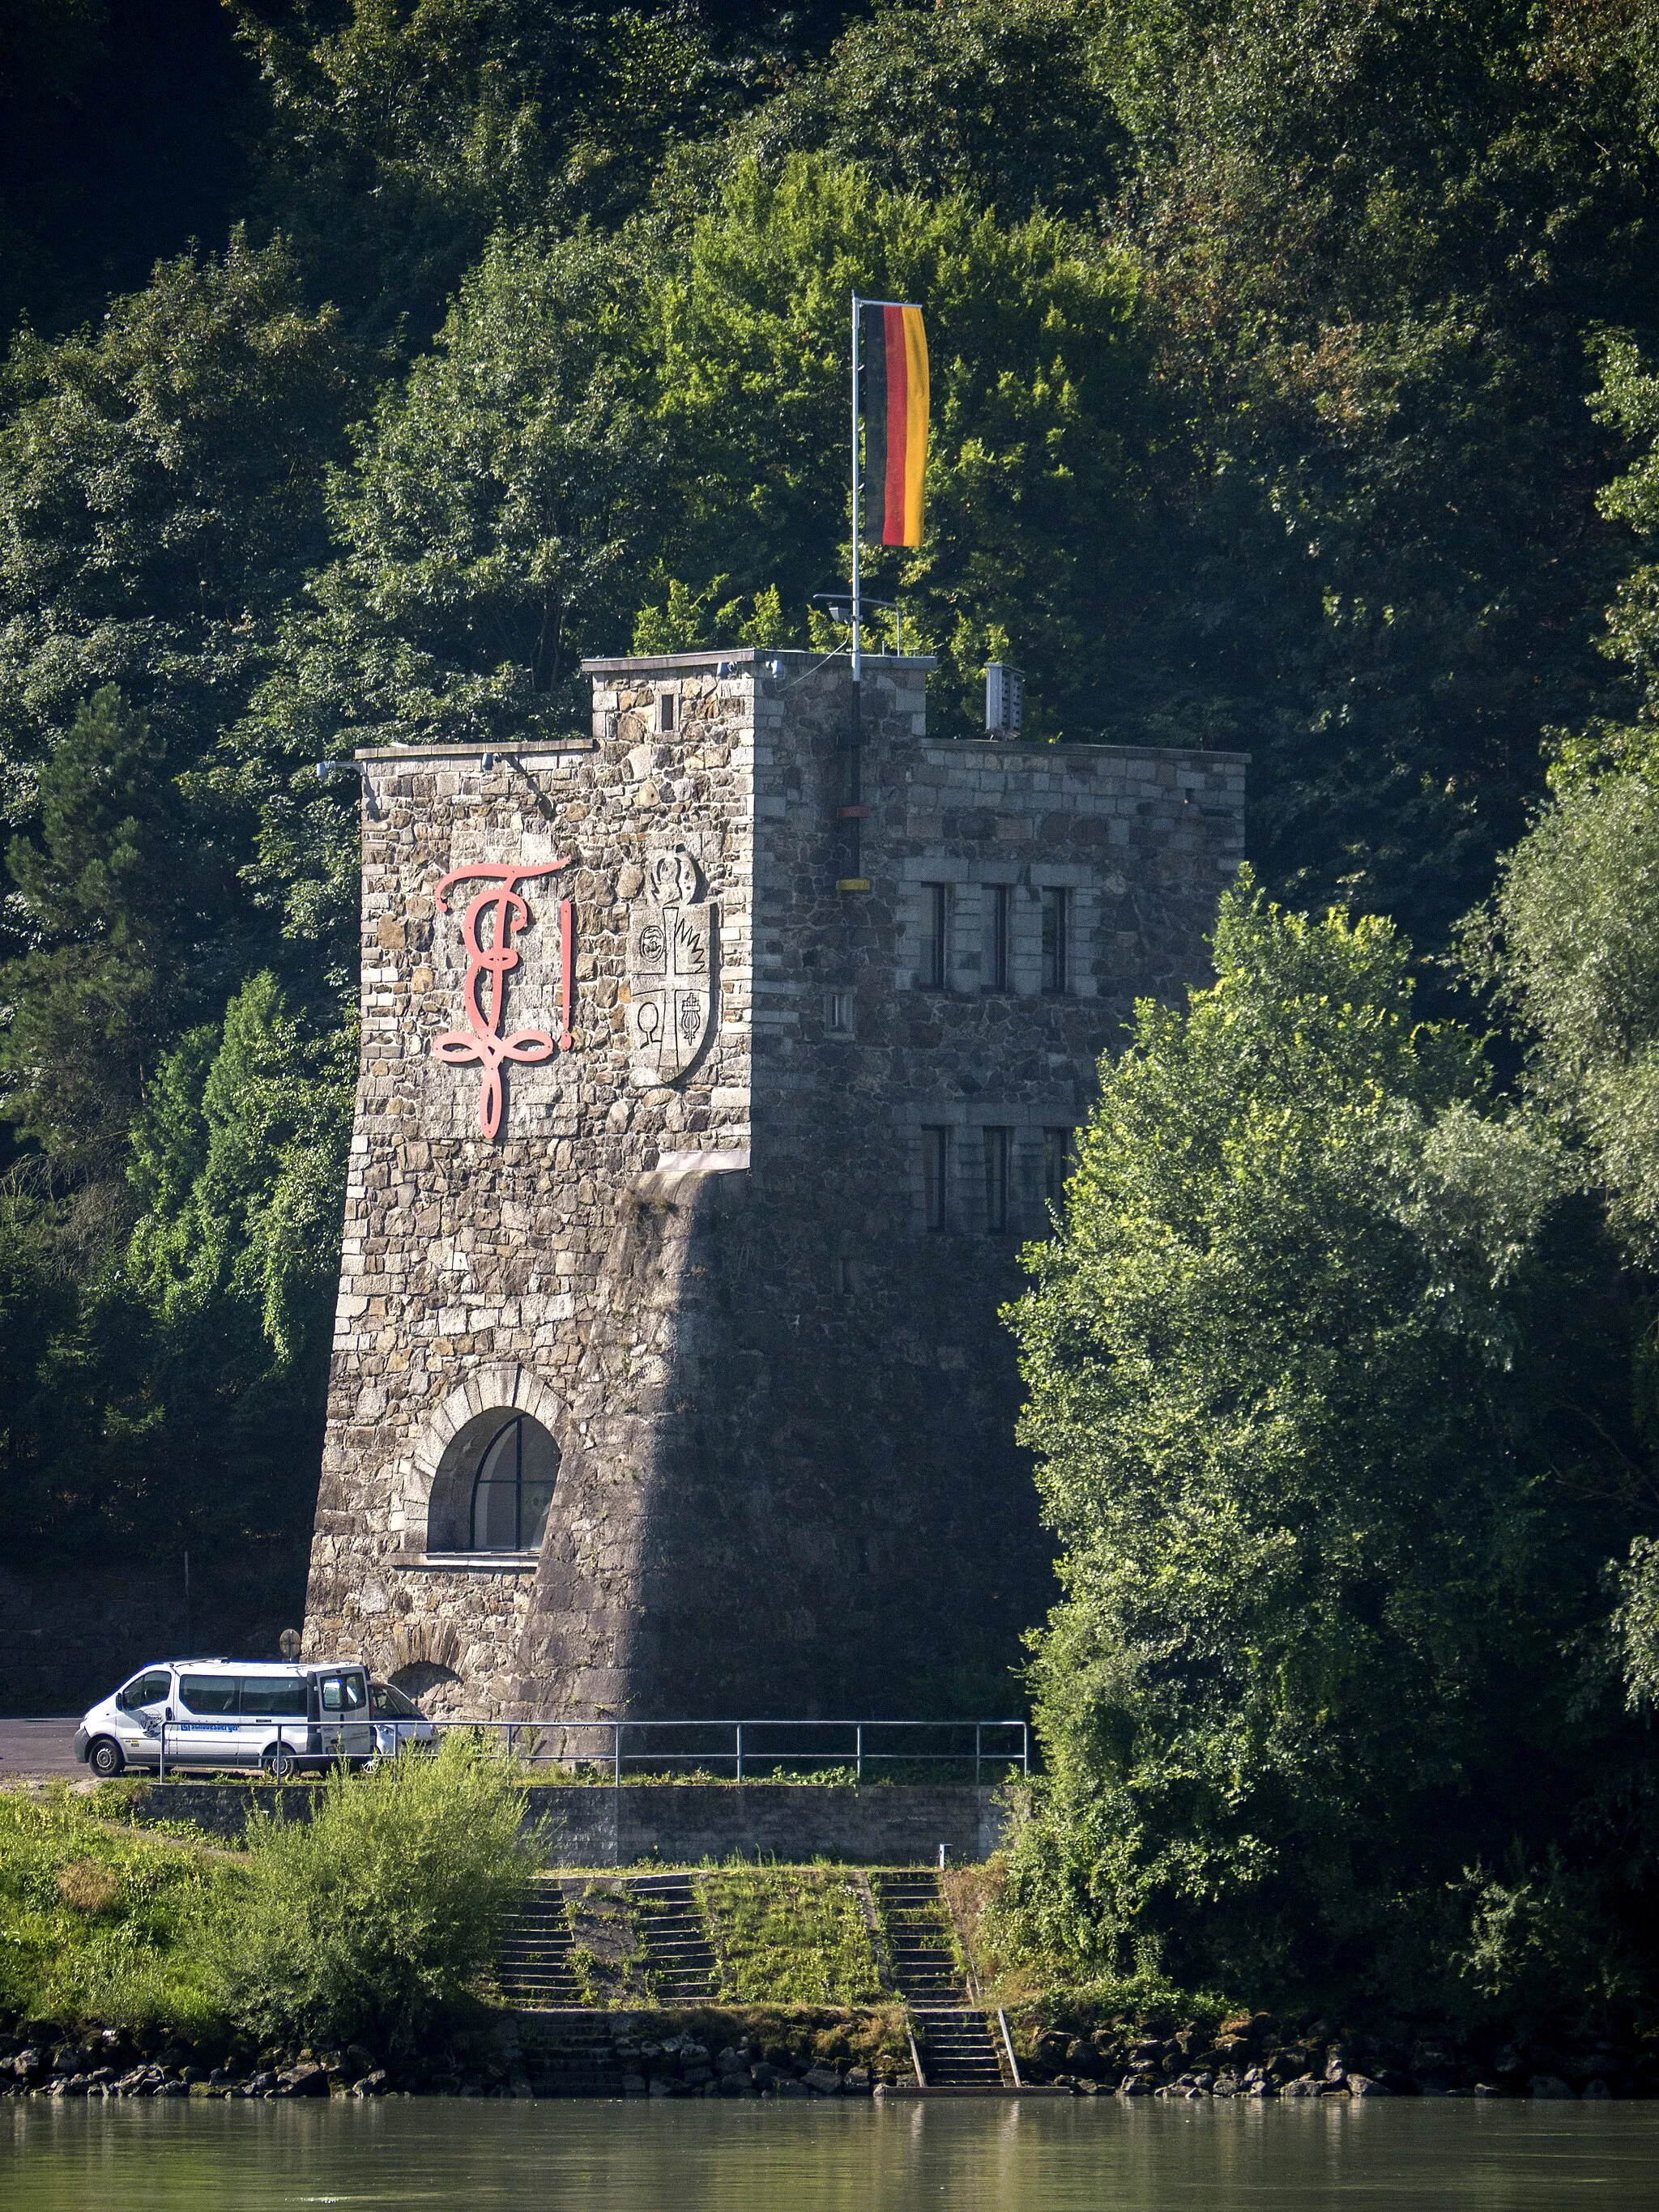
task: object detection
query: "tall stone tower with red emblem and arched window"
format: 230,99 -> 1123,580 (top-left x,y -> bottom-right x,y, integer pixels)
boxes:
305,653 -> 1245,1719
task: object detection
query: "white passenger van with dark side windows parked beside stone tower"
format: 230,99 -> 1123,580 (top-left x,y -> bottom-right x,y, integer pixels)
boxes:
75,1659 -> 376,1779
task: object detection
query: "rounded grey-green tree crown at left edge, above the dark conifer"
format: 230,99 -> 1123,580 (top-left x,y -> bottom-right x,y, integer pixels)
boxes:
0,237 -> 360,803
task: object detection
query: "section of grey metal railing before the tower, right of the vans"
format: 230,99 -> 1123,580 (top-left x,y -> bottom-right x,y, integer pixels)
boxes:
436,1719 -> 1030,1783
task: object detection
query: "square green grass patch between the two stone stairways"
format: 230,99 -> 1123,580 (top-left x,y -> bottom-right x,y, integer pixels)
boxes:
699,1867 -> 883,2006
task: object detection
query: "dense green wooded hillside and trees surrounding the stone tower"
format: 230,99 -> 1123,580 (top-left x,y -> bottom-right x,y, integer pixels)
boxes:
0,0 -> 1659,2026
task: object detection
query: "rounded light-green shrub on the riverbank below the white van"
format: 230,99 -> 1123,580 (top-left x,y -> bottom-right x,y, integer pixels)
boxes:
215,1734 -> 538,2048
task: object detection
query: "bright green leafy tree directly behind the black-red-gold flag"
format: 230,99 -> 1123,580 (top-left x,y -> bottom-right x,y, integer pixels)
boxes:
659,157 -> 1162,736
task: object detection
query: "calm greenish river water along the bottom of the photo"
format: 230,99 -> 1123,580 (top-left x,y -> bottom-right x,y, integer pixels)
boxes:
0,2097 -> 1659,2212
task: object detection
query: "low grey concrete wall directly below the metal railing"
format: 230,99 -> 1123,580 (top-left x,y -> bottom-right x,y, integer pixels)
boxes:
117,1780 -> 1004,1867
